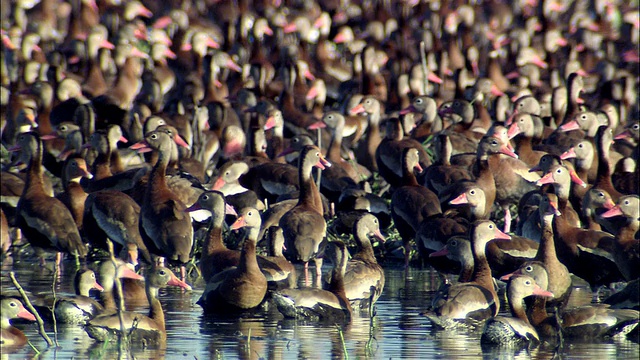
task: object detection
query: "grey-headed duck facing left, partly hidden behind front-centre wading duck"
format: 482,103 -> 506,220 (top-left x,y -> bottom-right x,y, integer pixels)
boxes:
186,191 -> 240,281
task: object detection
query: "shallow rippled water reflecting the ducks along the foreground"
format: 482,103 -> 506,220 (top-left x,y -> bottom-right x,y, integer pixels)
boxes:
1,260 -> 639,359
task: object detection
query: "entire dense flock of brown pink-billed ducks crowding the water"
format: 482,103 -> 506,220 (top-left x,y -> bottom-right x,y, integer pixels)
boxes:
0,0 -> 640,354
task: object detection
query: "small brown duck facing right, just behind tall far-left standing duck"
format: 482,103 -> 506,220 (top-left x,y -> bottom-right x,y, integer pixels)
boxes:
56,156 -> 93,230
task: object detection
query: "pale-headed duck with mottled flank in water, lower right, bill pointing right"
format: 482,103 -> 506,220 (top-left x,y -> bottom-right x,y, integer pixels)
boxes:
480,275 -> 554,348
